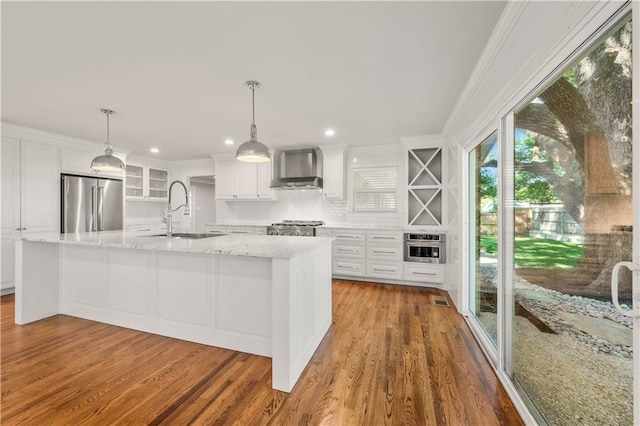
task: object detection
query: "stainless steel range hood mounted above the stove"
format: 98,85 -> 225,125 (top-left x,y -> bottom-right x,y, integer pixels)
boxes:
270,148 -> 322,189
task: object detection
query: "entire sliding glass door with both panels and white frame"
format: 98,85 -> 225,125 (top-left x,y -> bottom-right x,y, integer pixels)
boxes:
466,10 -> 640,425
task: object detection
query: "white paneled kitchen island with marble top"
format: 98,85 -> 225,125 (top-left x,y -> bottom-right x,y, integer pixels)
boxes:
15,231 -> 332,392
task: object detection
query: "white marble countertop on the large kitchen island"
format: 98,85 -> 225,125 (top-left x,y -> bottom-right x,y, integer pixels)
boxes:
17,231 -> 333,259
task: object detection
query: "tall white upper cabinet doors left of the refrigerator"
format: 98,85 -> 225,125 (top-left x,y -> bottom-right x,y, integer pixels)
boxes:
2,137 -> 60,233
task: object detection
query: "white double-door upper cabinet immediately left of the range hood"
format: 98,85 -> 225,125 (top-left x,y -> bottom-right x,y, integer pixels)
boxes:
216,160 -> 278,200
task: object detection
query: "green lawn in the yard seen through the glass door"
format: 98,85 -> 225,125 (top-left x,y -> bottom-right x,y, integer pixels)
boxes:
480,236 -> 582,269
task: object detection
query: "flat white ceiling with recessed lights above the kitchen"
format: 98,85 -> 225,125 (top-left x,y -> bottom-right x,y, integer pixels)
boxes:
2,1 -> 505,160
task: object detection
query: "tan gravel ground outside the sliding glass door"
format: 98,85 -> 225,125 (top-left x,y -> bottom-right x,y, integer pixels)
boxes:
480,265 -> 633,426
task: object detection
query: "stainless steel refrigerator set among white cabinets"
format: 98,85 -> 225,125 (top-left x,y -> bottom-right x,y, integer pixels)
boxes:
60,173 -> 124,233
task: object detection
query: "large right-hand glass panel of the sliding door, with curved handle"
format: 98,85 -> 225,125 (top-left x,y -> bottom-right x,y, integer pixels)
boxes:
503,17 -> 640,425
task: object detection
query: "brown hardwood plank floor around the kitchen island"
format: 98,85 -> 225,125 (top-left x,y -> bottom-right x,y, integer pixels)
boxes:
0,280 -> 522,426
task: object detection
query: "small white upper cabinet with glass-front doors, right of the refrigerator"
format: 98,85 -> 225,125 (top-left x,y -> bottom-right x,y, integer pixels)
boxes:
125,164 -> 169,202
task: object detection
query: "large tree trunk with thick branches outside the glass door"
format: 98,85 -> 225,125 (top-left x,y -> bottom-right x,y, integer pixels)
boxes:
516,21 -> 633,299
